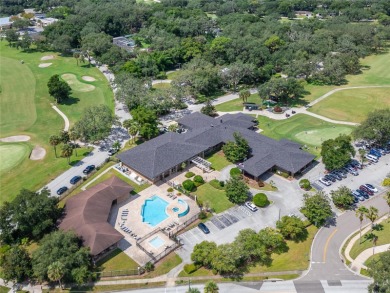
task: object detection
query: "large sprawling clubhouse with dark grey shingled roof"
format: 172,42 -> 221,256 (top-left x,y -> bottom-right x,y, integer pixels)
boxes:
118,112 -> 315,183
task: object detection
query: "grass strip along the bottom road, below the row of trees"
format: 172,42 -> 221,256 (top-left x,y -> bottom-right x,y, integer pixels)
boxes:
179,226 -> 318,277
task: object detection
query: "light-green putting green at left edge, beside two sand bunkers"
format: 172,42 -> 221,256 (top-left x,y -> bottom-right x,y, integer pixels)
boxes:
0,143 -> 31,174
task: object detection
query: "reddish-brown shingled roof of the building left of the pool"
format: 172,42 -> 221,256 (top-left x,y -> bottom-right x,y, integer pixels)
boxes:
60,176 -> 133,255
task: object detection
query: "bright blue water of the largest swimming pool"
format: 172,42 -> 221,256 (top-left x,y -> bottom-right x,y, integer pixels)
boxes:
141,195 -> 168,227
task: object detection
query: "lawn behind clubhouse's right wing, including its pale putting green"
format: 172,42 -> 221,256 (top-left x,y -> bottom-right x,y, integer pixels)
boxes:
258,114 -> 353,155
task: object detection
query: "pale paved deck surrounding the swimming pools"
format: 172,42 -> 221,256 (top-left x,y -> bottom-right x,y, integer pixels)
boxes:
110,167 -> 209,266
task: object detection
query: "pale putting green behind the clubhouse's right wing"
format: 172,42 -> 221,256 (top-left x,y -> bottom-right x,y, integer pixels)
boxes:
294,125 -> 352,146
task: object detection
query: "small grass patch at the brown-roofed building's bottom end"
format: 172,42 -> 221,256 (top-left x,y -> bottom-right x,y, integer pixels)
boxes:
97,248 -> 139,272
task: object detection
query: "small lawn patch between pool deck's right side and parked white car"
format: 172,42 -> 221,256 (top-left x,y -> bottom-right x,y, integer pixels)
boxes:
196,183 -> 234,213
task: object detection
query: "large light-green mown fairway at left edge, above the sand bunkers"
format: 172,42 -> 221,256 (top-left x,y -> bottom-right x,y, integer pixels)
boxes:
0,56 -> 37,136
